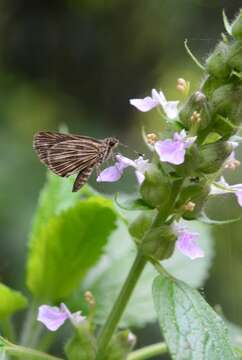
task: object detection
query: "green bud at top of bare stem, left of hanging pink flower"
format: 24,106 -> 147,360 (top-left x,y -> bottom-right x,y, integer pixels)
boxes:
139,225 -> 176,260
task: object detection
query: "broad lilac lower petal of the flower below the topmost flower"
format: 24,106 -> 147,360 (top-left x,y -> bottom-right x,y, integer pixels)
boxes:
155,139 -> 185,165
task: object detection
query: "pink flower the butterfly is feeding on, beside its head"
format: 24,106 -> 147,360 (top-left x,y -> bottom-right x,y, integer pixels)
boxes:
97,154 -> 150,184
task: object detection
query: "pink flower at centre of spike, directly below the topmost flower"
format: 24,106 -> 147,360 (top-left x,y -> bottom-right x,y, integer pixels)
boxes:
155,130 -> 197,165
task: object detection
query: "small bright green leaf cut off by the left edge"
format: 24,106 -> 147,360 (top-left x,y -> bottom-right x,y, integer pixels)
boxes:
0,284 -> 28,319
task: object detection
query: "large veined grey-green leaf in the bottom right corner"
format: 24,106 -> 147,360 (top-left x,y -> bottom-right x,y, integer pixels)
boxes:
153,276 -> 236,360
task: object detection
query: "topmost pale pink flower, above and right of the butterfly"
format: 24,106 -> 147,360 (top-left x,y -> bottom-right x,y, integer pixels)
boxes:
129,89 -> 179,120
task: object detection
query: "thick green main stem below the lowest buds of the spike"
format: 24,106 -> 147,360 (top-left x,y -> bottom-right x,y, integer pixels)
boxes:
96,252 -> 147,360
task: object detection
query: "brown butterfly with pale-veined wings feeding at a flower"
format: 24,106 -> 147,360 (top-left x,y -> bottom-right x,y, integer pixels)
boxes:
33,131 -> 119,192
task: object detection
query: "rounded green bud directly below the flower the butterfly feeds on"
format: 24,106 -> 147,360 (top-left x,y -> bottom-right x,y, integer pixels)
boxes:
140,166 -> 171,207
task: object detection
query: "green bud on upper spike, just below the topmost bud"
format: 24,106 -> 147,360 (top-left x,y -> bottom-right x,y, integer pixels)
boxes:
206,41 -> 231,78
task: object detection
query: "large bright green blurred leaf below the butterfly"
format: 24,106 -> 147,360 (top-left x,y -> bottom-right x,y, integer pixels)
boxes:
27,193 -> 116,302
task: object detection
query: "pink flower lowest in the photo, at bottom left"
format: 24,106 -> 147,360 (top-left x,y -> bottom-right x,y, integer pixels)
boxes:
37,303 -> 85,331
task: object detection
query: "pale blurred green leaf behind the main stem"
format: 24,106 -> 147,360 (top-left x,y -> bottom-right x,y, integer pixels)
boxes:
82,221 -> 213,327
